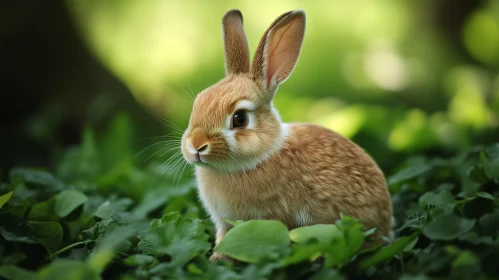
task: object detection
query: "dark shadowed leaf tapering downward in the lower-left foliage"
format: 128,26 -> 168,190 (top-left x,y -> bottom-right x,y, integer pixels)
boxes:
28,222 -> 64,254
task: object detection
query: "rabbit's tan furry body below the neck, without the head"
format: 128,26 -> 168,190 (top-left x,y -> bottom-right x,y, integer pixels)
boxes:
196,124 -> 392,241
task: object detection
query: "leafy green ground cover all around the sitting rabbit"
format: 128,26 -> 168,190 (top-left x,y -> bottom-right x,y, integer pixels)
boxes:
0,116 -> 499,280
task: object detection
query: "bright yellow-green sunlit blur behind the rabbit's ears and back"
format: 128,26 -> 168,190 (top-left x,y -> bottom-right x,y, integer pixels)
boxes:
67,0 -> 499,155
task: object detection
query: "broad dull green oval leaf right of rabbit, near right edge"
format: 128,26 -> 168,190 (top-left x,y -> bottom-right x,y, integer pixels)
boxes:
423,214 -> 476,240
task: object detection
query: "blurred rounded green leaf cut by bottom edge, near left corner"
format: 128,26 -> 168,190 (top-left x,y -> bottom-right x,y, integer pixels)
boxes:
37,260 -> 101,280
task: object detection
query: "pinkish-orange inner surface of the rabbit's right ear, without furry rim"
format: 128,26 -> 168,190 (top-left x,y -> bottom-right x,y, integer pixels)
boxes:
267,17 -> 303,85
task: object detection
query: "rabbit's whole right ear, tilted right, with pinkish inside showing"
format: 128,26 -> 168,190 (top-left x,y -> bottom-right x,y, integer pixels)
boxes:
251,10 -> 306,93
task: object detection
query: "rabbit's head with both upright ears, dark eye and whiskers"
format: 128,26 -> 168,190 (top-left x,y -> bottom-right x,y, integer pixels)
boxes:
181,10 -> 305,172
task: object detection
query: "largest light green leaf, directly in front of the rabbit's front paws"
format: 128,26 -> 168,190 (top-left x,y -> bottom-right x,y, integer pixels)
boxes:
215,220 -> 290,263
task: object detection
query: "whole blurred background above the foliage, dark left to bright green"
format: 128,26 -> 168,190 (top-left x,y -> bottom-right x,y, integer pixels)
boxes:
0,0 -> 499,177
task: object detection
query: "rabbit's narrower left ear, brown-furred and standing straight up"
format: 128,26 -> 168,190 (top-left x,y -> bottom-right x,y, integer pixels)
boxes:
222,10 -> 250,76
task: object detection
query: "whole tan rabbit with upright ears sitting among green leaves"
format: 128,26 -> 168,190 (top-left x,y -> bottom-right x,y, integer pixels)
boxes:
180,9 -> 393,261
